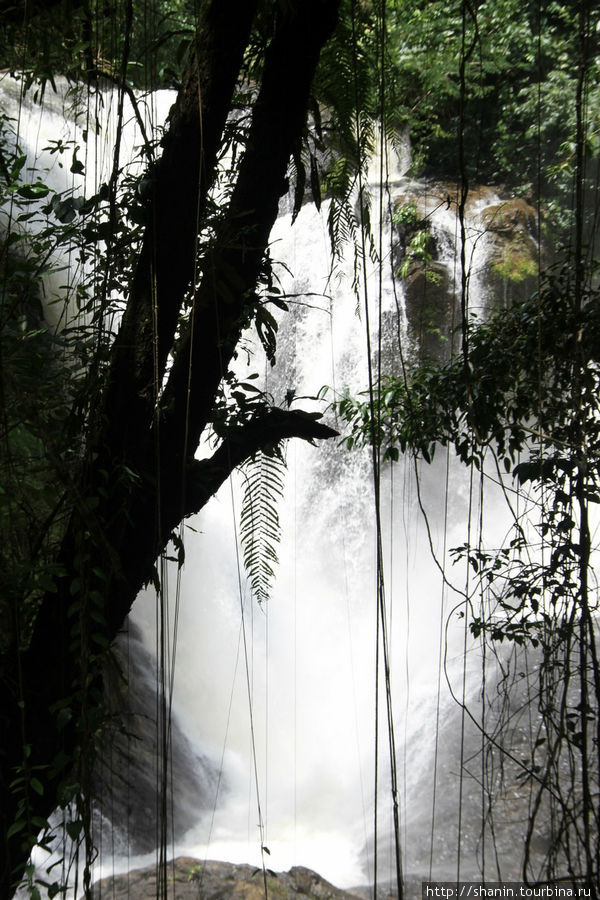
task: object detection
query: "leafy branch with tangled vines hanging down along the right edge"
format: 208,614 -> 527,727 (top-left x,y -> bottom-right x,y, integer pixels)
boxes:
337,266 -> 600,891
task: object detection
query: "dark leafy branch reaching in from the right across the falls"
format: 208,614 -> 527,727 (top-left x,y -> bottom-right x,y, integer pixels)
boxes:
337,268 -> 600,480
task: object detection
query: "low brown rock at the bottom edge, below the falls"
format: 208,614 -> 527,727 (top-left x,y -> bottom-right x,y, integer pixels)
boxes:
93,856 -> 364,900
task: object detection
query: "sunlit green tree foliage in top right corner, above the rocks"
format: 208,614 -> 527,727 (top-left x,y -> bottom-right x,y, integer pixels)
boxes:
388,0 -> 599,215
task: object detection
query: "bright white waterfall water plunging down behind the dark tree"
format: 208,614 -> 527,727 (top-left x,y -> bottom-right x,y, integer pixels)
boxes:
3,77 -> 544,886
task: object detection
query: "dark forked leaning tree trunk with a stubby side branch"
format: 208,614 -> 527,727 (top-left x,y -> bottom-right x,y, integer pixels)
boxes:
0,0 -> 339,900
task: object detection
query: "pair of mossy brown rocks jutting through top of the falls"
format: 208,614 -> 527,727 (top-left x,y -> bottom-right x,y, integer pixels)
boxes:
393,182 -> 539,361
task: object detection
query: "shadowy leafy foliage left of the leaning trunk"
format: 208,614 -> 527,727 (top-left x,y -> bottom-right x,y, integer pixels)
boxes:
0,79 -> 157,650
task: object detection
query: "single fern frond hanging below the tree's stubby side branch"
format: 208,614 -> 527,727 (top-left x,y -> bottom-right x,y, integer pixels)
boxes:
240,447 -> 285,603
